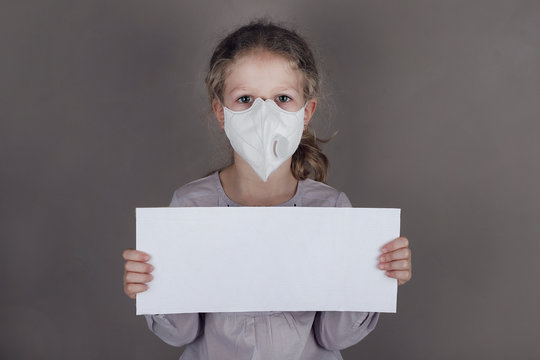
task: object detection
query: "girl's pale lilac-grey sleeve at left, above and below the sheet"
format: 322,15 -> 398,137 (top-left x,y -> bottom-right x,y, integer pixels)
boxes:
144,191 -> 204,347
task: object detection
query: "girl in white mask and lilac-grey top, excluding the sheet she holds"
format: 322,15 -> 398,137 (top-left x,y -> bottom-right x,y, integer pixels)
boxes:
123,20 -> 411,360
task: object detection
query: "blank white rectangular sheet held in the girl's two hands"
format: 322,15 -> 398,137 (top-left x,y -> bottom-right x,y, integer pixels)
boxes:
136,206 -> 401,315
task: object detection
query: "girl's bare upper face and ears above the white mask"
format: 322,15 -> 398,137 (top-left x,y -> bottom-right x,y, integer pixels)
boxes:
212,51 -> 317,129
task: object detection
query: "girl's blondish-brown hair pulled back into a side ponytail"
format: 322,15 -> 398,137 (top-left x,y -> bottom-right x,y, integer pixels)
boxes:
205,18 -> 337,183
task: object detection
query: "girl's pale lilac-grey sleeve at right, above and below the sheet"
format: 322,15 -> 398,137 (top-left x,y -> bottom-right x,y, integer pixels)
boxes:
313,192 -> 379,350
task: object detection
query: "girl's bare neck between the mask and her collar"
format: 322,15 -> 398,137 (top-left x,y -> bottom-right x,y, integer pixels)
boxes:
219,152 -> 298,206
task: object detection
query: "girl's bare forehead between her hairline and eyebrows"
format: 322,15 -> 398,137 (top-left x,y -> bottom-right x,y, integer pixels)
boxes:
225,50 -> 303,92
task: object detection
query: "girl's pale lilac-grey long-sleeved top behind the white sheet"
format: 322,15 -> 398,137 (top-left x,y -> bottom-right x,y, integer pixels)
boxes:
145,171 -> 379,360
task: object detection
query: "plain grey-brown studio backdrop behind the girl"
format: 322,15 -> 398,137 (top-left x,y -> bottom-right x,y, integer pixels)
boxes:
0,0 -> 540,359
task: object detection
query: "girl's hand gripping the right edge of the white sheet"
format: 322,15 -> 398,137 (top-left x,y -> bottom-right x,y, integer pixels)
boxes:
379,236 -> 412,285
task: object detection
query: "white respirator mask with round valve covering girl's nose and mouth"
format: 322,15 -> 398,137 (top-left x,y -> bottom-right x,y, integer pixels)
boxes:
223,97 -> 307,182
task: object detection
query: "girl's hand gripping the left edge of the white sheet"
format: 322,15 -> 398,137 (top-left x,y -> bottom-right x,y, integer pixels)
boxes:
122,249 -> 154,299
